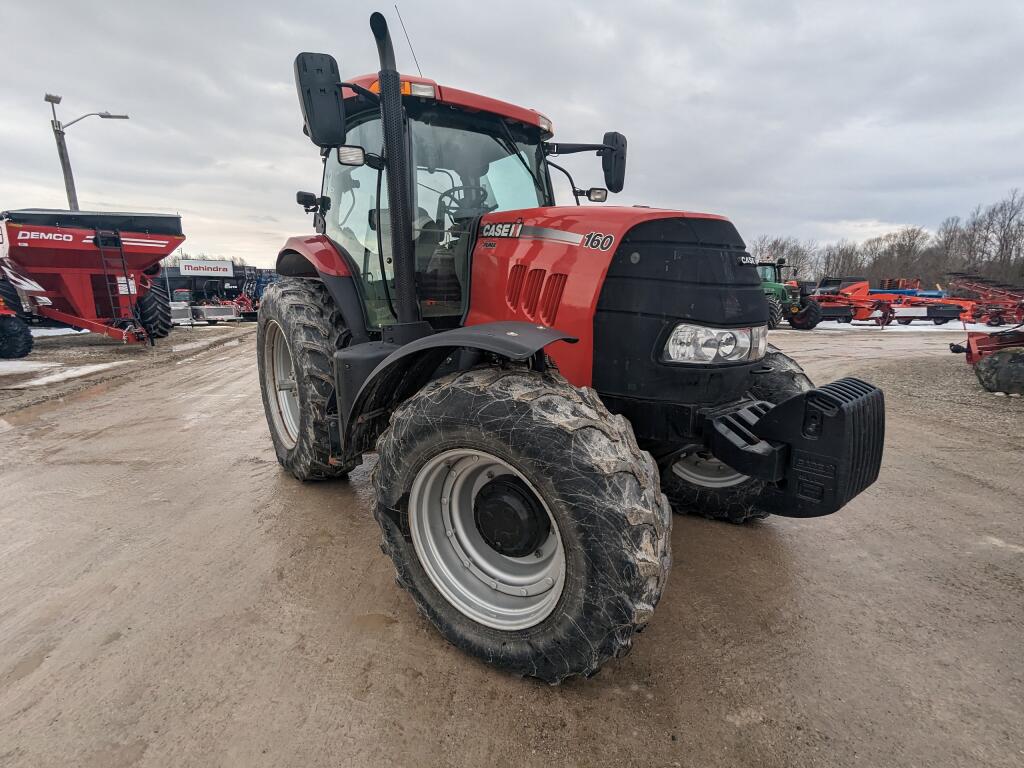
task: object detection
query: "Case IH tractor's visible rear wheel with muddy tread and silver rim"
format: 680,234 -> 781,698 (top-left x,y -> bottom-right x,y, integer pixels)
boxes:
256,279 -> 355,480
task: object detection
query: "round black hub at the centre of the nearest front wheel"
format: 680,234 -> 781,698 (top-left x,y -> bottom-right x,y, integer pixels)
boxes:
473,475 -> 551,557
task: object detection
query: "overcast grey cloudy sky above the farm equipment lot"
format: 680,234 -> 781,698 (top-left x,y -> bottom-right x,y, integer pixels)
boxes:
0,0 -> 1024,265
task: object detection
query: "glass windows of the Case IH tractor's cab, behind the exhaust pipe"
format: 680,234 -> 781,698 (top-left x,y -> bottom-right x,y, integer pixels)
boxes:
323,102 -> 553,327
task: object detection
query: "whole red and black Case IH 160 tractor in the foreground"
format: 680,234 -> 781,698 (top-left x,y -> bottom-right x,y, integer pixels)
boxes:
257,13 -> 885,683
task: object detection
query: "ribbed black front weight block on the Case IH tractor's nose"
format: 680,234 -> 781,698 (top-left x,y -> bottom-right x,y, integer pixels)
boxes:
707,378 -> 886,517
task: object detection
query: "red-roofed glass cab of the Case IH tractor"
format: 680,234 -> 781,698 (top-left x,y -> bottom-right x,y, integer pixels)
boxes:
300,75 -> 626,329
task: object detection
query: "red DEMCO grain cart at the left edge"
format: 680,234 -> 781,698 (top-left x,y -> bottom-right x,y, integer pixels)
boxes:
0,210 -> 184,343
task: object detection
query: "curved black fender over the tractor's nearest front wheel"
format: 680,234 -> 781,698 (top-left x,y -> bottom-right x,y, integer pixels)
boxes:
335,321 -> 578,456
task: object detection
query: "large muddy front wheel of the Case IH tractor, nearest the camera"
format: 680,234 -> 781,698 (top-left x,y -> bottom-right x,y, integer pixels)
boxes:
373,368 -> 672,684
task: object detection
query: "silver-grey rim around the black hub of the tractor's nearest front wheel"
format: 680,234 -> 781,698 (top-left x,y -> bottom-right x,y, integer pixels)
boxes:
409,449 -> 565,631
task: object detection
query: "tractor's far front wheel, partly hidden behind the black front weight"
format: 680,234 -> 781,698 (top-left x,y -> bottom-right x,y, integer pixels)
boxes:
662,344 -> 814,523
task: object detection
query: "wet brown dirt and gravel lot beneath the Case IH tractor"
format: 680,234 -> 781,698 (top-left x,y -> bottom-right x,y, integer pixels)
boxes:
0,332 -> 1024,768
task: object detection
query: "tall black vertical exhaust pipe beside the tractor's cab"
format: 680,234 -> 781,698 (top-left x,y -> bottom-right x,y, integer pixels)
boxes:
370,13 -> 420,325
